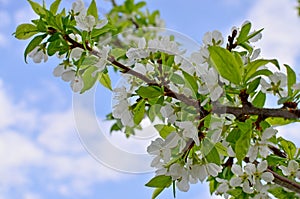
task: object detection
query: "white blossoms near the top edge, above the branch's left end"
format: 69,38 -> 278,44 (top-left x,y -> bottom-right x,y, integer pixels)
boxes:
72,0 -> 108,32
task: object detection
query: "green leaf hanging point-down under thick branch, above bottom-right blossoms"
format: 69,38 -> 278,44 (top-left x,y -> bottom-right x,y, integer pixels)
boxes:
234,126 -> 252,162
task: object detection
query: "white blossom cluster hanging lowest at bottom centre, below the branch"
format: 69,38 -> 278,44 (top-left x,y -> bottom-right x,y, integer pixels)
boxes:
147,134 -> 222,191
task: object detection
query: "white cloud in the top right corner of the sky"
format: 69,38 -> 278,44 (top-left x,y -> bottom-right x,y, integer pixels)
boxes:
248,0 -> 300,66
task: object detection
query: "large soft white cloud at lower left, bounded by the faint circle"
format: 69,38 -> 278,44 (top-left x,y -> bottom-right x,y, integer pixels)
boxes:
0,81 -> 126,199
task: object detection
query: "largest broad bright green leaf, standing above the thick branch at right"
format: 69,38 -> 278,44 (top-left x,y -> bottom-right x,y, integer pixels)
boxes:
208,46 -> 242,85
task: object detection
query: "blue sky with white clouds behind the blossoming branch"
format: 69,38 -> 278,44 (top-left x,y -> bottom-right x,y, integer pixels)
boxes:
0,0 -> 300,199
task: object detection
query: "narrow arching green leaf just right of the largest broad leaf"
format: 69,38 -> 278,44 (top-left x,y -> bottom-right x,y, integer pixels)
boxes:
244,59 -> 280,82
